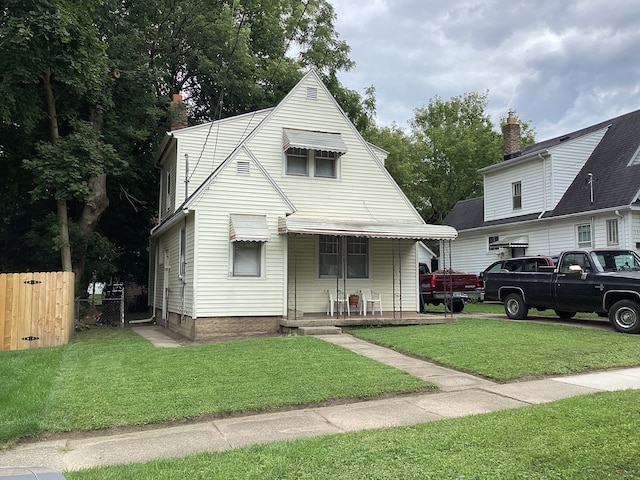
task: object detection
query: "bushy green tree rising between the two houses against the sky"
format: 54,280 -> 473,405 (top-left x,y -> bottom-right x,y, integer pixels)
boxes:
366,92 -> 535,223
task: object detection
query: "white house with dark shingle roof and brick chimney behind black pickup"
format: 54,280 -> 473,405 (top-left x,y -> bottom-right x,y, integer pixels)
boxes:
444,110 -> 640,273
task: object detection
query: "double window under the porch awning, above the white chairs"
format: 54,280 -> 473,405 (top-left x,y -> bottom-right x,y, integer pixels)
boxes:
318,235 -> 369,278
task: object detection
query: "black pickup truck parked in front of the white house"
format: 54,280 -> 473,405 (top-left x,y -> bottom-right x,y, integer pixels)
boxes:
484,249 -> 640,333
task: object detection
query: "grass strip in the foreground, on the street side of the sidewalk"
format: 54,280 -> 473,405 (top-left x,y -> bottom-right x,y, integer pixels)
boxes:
65,391 -> 640,480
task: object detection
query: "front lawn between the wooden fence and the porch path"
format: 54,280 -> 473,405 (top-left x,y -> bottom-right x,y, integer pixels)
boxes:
0,328 -> 433,442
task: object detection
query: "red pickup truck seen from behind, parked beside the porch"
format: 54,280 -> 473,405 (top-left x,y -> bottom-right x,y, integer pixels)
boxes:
420,263 -> 481,313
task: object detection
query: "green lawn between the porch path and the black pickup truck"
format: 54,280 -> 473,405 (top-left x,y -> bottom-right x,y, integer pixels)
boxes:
351,318 -> 640,381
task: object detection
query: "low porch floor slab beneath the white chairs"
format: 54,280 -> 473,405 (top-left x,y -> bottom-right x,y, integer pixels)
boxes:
280,312 -> 456,328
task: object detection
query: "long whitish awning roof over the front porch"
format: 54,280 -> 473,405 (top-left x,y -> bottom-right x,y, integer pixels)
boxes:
278,214 -> 458,240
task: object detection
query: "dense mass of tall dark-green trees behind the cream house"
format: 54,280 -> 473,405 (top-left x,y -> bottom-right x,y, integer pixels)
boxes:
0,0 -> 370,292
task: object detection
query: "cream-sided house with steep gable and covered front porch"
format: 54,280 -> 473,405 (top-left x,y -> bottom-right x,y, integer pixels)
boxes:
149,72 -> 457,339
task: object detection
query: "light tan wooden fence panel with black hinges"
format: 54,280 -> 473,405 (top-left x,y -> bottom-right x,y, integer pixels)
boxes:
0,272 -> 74,350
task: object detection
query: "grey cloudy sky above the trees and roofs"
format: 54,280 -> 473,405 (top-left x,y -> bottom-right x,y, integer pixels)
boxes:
329,0 -> 640,141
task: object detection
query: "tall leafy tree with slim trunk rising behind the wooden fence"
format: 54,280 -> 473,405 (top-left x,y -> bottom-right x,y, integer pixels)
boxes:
0,0 -> 121,288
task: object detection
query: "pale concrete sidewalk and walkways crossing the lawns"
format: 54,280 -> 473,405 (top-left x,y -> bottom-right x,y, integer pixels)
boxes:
0,326 -> 640,471
